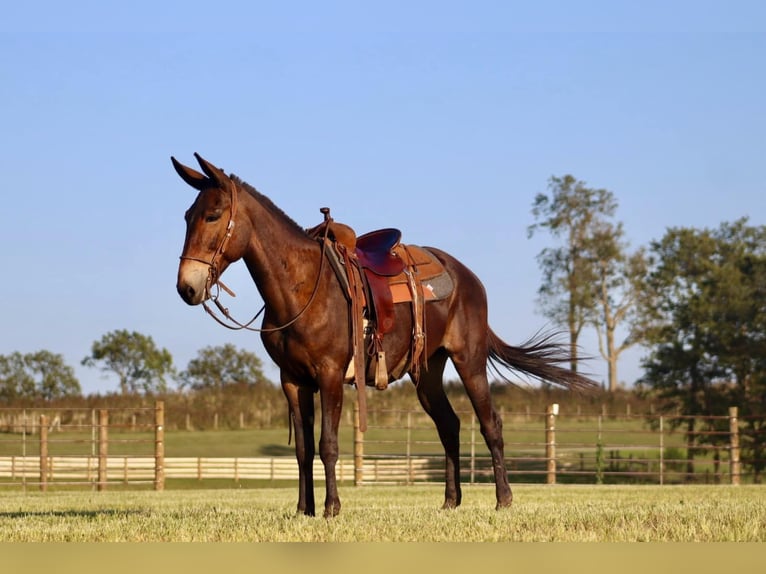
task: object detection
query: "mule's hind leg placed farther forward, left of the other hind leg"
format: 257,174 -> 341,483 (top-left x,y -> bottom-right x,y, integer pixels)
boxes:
415,351 -> 462,508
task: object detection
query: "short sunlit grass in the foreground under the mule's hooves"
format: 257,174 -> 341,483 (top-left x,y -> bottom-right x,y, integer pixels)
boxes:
0,485 -> 766,542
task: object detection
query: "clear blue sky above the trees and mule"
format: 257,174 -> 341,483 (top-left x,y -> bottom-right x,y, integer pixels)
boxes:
0,0 -> 766,393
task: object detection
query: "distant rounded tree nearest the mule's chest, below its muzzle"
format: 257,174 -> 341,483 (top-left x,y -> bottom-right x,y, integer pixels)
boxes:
178,343 -> 268,391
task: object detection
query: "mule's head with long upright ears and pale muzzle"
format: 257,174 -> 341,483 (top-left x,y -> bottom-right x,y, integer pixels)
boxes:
170,153 -> 242,305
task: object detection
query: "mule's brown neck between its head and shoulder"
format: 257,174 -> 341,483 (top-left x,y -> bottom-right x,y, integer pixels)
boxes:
241,191 -> 321,320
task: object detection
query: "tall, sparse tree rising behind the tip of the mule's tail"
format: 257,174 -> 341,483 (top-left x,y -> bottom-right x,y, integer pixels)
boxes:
528,175 -> 617,371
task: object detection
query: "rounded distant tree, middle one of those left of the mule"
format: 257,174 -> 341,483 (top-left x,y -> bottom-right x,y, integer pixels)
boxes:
82,329 -> 174,395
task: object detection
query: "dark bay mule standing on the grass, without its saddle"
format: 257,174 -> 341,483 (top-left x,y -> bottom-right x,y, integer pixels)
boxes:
171,153 -> 597,517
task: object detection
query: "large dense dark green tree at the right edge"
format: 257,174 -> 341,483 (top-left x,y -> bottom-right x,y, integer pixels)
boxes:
641,219 -> 766,482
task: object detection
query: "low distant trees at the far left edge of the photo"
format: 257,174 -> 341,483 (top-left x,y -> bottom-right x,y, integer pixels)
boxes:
0,350 -> 82,402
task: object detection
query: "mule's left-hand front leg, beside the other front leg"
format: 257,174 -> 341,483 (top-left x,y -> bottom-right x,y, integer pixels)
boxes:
282,380 -> 316,516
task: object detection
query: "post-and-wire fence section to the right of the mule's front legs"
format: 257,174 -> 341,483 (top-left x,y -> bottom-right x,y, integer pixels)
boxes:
354,404 -> 752,484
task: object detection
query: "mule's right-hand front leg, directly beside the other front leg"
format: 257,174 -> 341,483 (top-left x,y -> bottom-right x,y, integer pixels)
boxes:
319,377 -> 344,518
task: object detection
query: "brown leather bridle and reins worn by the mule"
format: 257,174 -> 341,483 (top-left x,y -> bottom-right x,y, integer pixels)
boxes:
180,182 -> 328,333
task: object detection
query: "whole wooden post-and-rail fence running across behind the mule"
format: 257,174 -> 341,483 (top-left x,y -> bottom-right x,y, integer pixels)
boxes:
0,402 -> 760,490
